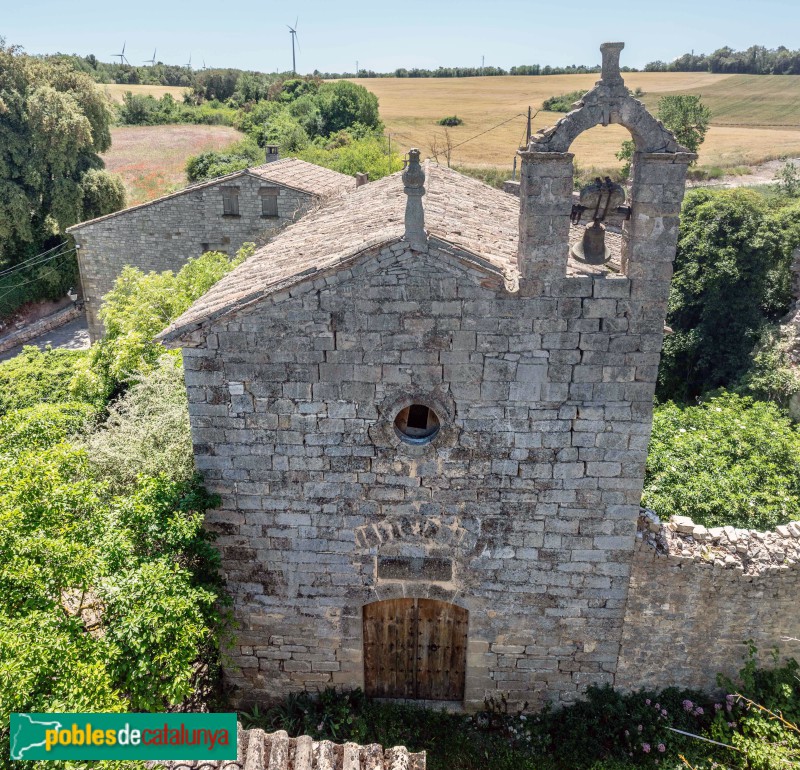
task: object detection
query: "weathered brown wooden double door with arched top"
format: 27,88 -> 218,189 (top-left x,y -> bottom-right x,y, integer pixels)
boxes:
364,599 -> 469,701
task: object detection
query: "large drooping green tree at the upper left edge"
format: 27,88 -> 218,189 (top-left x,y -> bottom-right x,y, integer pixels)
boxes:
0,39 -> 119,261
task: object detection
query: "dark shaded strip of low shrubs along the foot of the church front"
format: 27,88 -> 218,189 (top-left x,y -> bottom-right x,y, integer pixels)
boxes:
241,686 -> 728,770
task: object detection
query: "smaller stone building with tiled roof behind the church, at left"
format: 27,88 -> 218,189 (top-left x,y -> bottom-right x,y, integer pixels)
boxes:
67,158 -> 355,341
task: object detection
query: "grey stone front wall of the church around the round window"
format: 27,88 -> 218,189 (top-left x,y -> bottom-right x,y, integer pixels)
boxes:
184,242 -> 663,707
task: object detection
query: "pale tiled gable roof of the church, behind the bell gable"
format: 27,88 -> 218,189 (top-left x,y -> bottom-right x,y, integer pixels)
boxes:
158,161 -> 620,342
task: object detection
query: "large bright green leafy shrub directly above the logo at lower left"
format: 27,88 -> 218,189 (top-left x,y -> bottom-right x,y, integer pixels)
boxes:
0,432 -> 222,751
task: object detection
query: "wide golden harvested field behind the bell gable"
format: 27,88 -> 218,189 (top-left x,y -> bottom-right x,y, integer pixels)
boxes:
355,72 -> 800,168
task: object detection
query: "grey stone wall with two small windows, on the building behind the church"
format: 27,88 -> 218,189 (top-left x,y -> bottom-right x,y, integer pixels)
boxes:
73,174 -> 313,341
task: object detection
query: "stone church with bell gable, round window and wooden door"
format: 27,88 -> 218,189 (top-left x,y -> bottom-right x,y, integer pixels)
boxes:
161,43 -> 744,708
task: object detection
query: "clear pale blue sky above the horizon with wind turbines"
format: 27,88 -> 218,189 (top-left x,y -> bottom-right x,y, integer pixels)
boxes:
0,0 -> 800,72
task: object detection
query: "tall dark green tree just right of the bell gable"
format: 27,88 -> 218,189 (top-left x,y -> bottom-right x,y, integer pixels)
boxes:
657,190 -> 798,401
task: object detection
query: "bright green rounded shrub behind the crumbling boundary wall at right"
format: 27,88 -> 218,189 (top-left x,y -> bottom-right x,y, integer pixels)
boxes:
642,393 -> 800,530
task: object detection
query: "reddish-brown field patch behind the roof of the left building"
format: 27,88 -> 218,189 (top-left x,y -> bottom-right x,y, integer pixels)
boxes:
103,125 -> 242,206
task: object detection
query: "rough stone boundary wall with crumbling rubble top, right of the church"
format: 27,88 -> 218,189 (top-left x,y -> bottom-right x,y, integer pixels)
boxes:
615,511 -> 800,690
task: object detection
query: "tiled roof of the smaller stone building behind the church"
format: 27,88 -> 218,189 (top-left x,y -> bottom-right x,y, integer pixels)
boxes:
67,158 -> 355,233
